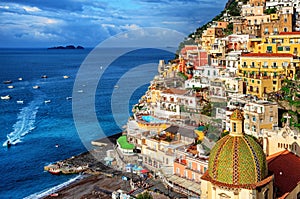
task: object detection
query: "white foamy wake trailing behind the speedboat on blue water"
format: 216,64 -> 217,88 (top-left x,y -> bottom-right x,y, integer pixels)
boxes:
3,101 -> 40,147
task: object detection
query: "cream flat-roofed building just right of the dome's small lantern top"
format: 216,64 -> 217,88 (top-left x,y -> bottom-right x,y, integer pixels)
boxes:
244,100 -> 278,137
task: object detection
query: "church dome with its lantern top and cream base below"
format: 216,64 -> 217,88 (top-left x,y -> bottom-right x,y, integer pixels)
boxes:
201,109 -> 273,199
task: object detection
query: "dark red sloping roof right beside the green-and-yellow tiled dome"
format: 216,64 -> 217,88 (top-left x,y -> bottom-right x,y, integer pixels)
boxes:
267,150 -> 300,198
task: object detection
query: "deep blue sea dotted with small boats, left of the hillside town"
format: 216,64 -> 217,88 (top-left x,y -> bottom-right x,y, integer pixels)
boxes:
0,48 -> 175,199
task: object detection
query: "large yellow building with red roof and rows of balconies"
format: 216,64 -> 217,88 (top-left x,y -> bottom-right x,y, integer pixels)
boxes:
238,53 -> 299,98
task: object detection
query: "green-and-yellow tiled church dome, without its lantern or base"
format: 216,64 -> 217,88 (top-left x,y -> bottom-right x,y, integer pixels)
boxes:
208,134 -> 268,187
